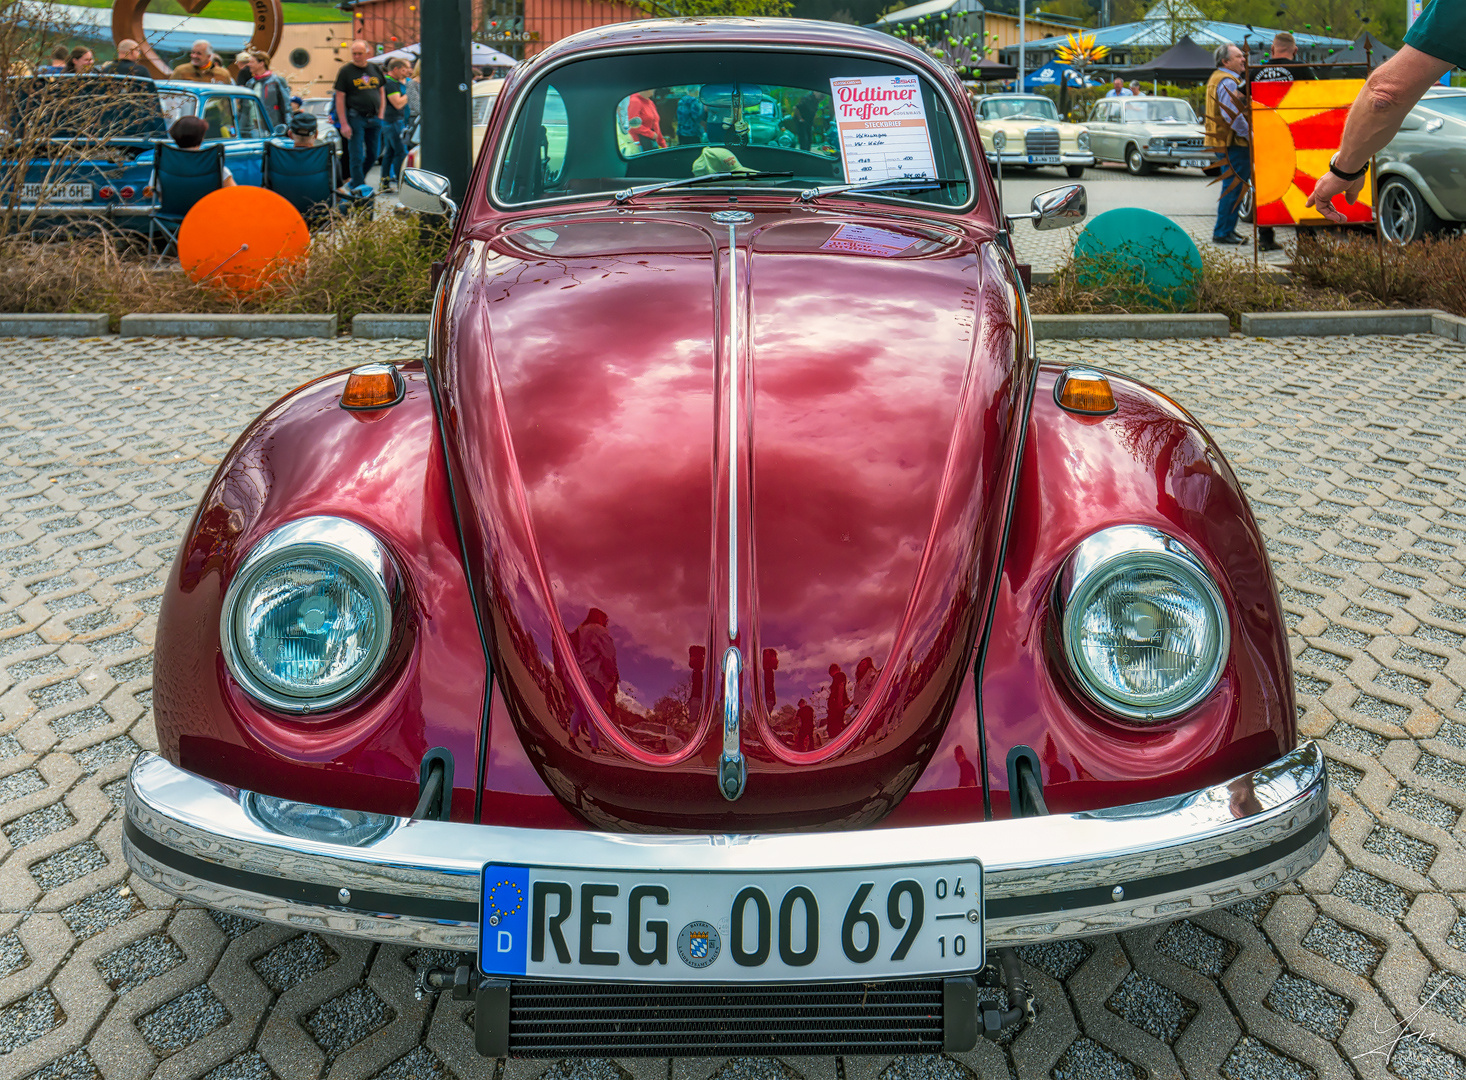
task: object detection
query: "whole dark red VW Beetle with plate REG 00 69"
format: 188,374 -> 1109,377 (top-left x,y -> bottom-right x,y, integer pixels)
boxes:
126,19 -> 1327,1057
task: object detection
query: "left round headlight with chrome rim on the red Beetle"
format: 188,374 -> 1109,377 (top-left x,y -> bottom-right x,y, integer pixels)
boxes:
220,517 -> 396,712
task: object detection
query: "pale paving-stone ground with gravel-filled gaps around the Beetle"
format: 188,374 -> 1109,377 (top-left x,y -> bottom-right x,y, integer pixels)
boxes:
0,337 -> 1466,1080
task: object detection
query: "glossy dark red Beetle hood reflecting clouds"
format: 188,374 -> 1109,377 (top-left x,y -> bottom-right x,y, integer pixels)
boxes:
434,211 -> 1031,829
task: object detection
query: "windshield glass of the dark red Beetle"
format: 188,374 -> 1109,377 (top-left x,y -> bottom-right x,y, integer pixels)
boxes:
494,51 -> 970,207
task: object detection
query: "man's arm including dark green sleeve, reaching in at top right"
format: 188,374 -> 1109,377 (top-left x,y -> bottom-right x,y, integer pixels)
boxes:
1305,0 -> 1466,223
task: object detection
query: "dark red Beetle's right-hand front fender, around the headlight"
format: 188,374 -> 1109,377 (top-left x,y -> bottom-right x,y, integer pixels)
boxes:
981,366 -> 1296,816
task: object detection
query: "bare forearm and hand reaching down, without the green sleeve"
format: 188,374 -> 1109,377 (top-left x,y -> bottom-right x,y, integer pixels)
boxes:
1306,45 -> 1451,221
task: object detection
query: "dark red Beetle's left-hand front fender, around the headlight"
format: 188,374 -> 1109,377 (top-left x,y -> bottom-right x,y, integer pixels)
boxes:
154,363 -> 498,819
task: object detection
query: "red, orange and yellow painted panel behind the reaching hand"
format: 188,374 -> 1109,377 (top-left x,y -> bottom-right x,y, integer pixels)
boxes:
1252,79 -> 1374,226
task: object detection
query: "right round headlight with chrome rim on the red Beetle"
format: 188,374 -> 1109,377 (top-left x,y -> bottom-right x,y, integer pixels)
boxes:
1058,525 -> 1230,722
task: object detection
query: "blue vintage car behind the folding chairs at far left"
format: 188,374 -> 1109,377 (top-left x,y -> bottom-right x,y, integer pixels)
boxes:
0,75 -> 273,232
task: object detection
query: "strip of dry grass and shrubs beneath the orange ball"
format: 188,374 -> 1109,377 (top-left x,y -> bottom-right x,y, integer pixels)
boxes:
0,214 -> 447,325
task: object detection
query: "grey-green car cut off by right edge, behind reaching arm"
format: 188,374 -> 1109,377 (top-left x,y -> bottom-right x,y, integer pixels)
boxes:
1375,86 -> 1466,243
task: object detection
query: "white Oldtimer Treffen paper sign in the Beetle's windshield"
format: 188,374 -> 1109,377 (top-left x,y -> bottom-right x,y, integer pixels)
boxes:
830,75 -> 937,183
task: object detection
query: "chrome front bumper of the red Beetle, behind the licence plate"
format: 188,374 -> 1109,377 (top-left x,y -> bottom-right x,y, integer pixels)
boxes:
123,743 -> 1328,951
